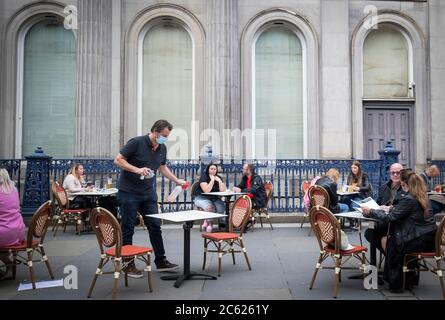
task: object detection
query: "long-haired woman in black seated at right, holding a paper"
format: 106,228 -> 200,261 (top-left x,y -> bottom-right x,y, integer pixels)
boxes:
362,170 -> 436,292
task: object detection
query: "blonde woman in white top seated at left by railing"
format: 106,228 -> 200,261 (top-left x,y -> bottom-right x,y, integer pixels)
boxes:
63,164 -> 92,209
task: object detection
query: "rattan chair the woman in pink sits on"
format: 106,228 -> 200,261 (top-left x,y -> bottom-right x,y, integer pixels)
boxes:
0,201 -> 54,289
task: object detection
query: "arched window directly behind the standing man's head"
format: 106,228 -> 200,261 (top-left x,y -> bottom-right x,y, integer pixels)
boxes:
139,19 -> 194,159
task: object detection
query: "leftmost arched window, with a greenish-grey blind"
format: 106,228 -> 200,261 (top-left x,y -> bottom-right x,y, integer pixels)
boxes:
19,20 -> 76,157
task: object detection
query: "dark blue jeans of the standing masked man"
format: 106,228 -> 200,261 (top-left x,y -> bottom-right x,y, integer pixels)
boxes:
117,188 -> 165,263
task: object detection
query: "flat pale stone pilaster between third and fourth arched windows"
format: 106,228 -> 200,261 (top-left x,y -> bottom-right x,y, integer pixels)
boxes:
320,0 -> 352,158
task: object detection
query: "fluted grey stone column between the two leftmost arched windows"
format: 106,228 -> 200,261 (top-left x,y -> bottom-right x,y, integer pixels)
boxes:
75,0 -> 112,157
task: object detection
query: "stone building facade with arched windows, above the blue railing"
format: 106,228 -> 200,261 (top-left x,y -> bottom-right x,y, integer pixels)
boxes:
0,0 -> 445,167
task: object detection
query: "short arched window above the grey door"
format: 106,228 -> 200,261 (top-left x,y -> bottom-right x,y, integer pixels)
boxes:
363,24 -> 411,98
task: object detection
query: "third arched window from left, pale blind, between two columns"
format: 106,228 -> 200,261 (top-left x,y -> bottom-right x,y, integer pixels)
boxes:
253,25 -> 304,159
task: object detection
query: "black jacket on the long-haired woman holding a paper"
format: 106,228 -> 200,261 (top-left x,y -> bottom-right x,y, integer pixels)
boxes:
370,193 -> 436,245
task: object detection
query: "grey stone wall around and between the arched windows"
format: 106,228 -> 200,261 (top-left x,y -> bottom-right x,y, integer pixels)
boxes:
0,0 -> 445,165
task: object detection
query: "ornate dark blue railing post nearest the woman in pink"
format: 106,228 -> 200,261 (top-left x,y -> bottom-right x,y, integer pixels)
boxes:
22,147 -> 52,213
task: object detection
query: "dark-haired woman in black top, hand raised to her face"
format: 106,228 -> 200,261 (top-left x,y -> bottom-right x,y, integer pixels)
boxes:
194,163 -> 226,232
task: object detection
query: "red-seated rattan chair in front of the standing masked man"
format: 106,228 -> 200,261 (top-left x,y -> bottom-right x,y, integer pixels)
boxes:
88,207 -> 153,299
